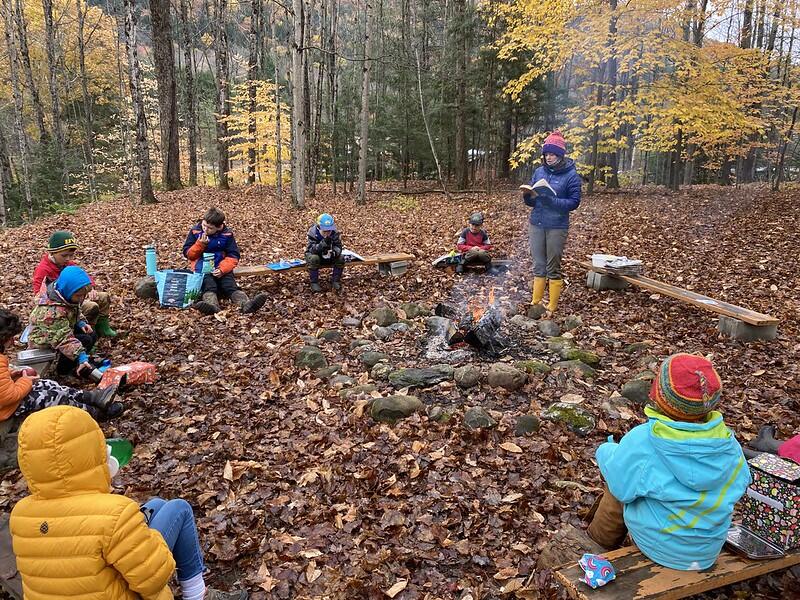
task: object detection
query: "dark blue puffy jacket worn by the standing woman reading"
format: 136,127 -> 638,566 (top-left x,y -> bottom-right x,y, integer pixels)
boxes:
523,158 -> 581,229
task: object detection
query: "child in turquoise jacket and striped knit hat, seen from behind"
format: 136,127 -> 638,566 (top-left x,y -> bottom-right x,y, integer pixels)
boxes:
587,354 -> 750,571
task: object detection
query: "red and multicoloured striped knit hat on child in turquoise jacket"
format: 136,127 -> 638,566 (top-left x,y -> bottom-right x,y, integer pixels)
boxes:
650,354 -> 722,421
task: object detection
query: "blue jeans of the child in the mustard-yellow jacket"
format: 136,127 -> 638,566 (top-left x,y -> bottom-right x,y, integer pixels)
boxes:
142,498 -> 205,581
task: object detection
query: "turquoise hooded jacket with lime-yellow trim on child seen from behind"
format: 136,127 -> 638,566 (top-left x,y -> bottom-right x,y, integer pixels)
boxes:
596,408 -> 750,571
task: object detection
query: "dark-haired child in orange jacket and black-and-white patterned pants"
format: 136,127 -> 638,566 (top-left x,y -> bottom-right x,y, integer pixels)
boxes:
0,309 -> 123,421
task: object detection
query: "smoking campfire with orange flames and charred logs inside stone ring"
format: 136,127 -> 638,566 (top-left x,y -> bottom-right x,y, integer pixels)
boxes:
435,287 -> 506,354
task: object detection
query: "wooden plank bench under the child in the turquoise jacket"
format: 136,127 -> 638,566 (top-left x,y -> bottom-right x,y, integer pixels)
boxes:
555,546 -> 800,600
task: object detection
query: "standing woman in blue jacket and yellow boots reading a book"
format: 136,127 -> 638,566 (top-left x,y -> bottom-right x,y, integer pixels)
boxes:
520,131 -> 581,313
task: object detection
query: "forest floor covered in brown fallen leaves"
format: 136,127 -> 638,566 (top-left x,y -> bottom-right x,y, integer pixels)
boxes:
0,187 -> 800,600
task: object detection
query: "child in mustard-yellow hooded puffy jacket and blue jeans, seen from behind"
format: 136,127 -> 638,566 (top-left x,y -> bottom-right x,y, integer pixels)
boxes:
10,406 -> 247,600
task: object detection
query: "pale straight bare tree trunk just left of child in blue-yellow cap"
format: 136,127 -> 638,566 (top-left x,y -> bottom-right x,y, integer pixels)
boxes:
292,0 -> 306,208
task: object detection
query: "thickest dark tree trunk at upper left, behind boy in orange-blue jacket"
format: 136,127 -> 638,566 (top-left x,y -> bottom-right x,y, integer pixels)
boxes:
150,0 -> 181,190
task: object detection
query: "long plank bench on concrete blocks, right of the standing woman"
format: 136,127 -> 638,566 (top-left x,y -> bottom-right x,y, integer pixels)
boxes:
579,261 -> 779,341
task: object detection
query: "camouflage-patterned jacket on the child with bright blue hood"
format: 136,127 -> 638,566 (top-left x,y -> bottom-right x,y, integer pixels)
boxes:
28,283 -> 85,360
